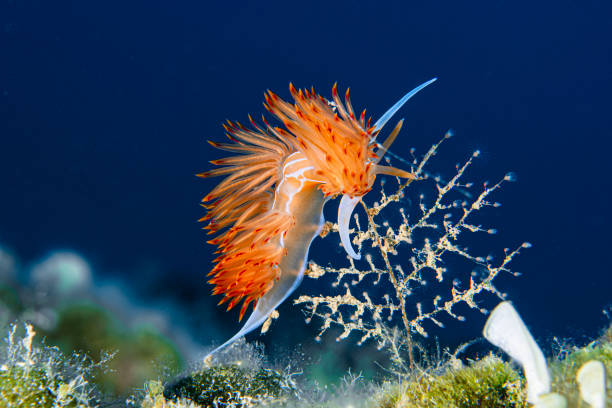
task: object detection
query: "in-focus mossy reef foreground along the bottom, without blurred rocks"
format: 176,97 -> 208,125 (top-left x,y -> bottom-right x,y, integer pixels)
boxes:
0,318 -> 612,408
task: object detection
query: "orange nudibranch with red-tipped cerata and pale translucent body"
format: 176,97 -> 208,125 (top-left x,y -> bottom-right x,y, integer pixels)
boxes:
198,78 -> 436,354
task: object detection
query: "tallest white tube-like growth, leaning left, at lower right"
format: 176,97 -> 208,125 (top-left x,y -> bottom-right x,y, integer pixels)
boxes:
483,302 -> 550,404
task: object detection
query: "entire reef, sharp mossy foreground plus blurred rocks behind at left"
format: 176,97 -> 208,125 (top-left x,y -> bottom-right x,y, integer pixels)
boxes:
0,236 -> 612,408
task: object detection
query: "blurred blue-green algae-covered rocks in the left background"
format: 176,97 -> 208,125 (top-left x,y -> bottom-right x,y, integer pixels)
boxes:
0,246 -> 185,400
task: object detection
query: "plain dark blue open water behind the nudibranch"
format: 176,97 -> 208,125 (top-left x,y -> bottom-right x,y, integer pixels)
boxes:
0,0 -> 612,370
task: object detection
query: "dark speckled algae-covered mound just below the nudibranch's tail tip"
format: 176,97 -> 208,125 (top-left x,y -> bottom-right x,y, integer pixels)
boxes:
163,364 -> 293,407
